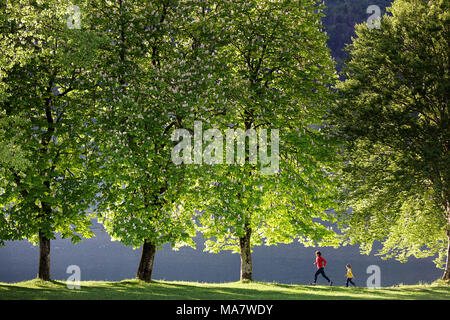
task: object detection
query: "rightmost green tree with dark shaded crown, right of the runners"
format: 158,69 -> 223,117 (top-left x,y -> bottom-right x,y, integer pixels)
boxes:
329,0 -> 450,279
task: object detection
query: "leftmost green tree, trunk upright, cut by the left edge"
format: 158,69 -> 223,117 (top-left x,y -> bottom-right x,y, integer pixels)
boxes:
0,0 -> 102,280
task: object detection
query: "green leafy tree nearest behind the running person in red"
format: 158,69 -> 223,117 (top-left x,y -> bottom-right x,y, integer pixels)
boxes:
192,0 -> 337,280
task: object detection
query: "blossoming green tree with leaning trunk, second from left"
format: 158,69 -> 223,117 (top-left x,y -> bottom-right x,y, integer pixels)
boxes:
88,0 -> 223,281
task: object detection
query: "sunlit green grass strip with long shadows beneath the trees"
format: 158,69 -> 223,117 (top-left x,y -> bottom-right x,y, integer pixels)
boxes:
0,280 -> 450,300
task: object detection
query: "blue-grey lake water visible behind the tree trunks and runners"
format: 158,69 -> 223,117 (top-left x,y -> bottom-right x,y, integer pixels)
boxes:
0,224 -> 442,286
